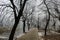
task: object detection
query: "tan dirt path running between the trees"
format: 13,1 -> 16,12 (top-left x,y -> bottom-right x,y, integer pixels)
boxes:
16,28 -> 38,40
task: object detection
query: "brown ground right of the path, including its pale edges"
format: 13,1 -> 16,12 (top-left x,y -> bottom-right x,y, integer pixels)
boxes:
39,32 -> 60,40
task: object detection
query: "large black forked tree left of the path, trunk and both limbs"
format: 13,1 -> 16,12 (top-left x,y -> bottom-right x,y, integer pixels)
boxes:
9,0 -> 27,40
